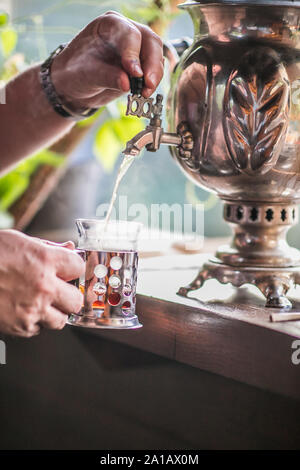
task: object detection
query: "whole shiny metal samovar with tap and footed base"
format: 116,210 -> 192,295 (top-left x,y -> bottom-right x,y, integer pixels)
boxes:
124,0 -> 300,308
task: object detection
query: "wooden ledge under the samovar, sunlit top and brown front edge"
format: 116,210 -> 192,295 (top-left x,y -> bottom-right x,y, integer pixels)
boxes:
78,255 -> 300,399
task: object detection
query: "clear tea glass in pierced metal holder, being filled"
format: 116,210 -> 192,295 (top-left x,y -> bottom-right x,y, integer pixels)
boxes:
68,219 -> 142,329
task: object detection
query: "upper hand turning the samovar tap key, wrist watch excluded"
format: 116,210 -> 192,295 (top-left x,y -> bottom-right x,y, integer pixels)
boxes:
51,11 -> 164,110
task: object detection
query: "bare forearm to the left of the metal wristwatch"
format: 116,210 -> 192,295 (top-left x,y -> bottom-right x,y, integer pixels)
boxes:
0,66 -> 74,171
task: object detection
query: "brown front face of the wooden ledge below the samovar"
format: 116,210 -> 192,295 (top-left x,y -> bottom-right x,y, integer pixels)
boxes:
74,295 -> 300,400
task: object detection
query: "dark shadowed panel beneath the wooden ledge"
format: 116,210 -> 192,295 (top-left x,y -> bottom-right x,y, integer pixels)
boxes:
0,328 -> 300,449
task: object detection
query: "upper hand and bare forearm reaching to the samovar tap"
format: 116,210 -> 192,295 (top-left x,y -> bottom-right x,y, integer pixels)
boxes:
0,12 -> 163,171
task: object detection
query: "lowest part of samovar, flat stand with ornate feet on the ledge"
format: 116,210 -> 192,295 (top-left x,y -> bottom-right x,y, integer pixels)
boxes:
177,258 -> 300,308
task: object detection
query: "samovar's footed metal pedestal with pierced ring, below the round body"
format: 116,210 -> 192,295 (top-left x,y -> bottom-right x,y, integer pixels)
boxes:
178,201 -> 300,308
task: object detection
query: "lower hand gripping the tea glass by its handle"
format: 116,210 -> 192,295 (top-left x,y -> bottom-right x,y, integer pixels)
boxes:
0,230 -> 84,337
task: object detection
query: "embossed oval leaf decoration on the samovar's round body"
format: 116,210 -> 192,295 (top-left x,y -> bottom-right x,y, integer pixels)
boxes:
223,47 -> 290,175
